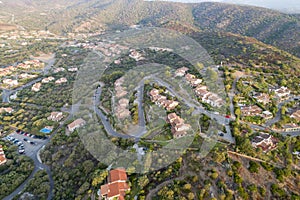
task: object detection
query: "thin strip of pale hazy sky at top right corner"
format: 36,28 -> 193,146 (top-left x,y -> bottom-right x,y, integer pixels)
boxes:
152,0 -> 300,13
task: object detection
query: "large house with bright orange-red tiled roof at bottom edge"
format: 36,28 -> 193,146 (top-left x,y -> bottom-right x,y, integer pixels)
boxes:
99,168 -> 130,200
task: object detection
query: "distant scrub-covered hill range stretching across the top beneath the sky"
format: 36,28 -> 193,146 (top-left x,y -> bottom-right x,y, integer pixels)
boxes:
0,0 -> 300,57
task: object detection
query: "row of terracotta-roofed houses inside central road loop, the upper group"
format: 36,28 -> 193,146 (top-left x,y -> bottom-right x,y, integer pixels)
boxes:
149,89 -> 179,111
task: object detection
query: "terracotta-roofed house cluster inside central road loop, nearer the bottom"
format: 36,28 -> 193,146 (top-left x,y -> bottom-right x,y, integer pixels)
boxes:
167,113 -> 191,138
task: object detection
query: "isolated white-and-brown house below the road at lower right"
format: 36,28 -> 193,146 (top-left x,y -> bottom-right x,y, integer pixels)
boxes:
251,133 -> 278,152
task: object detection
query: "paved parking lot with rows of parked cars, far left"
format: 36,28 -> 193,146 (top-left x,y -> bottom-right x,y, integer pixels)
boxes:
5,132 -> 45,157
